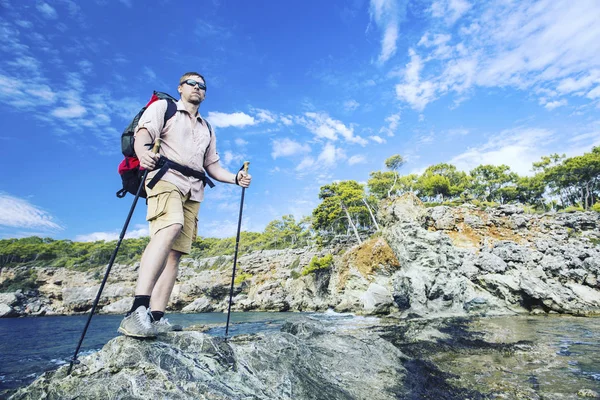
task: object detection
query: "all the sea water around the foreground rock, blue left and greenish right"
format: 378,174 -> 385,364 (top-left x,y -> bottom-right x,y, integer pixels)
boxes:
0,313 -> 600,399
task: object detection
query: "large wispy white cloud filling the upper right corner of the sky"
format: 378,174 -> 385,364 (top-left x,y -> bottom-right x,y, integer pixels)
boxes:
396,0 -> 600,110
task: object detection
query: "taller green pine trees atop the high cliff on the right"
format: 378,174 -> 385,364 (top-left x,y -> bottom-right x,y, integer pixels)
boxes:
312,147 -> 600,242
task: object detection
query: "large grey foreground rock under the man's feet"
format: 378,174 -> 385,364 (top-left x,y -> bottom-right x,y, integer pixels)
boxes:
13,321 -> 406,400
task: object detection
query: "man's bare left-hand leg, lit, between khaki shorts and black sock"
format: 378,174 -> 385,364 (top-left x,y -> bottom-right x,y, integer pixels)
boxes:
135,224 -> 182,296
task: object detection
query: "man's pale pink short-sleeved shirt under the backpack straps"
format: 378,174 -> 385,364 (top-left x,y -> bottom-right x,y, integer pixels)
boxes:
135,100 -> 219,201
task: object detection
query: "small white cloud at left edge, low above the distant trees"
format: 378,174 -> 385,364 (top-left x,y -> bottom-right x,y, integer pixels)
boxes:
0,192 -> 63,231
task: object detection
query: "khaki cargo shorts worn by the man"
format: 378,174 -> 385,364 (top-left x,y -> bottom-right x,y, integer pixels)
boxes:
146,180 -> 200,254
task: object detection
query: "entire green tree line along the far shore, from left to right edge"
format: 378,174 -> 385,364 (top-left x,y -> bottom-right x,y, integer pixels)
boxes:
0,147 -> 600,270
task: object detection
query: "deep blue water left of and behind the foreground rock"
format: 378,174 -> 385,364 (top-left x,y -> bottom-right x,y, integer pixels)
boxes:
0,312 -> 303,397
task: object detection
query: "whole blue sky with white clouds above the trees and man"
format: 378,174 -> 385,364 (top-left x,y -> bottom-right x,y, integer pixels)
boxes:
0,0 -> 600,240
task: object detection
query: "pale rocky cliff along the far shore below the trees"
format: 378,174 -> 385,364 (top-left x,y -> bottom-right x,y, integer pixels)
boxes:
0,196 -> 600,317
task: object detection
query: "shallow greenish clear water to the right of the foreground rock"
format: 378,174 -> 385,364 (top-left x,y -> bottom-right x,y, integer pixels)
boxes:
431,316 -> 600,399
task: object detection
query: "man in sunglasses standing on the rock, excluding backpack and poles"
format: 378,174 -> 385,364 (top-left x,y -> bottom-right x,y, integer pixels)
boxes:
119,72 -> 251,338
